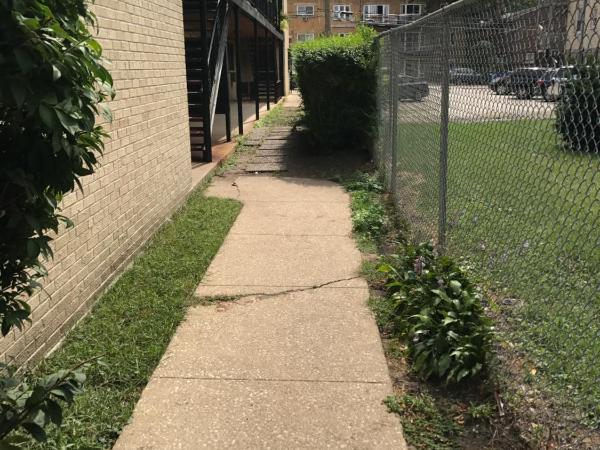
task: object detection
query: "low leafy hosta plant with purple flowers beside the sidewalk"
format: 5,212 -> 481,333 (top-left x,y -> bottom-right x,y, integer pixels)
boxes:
379,244 -> 492,382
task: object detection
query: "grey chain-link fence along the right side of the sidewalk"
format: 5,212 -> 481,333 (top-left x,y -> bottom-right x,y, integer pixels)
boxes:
375,0 -> 600,438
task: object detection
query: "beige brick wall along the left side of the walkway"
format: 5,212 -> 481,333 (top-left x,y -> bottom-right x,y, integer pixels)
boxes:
0,0 -> 191,364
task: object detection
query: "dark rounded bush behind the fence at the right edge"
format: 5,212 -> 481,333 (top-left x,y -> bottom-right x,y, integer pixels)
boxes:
556,59 -> 600,154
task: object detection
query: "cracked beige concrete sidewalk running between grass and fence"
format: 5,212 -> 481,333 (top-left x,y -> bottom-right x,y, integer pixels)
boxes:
114,176 -> 406,450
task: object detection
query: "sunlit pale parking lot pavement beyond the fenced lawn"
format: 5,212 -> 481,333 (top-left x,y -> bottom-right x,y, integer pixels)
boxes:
398,84 -> 555,123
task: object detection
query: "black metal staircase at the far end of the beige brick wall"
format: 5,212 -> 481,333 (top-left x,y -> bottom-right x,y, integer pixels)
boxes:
183,0 -> 229,161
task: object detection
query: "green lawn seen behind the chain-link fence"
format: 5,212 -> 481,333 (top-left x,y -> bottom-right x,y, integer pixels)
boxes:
398,120 -> 600,426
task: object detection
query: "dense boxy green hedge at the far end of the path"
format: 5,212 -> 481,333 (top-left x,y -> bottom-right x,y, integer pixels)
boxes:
292,27 -> 376,148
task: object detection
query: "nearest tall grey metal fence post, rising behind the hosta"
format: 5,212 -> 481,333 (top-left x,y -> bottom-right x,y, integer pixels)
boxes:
438,17 -> 450,252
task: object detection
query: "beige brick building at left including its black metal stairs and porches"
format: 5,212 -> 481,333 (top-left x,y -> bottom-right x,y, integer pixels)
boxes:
0,0 -> 287,365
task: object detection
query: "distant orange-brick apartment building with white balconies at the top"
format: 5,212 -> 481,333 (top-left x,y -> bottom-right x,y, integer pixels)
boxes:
288,0 -> 441,43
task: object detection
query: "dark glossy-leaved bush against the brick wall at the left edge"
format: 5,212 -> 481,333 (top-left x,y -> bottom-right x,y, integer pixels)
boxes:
0,0 -> 112,445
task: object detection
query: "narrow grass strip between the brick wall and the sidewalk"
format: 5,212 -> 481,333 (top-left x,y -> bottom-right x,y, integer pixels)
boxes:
29,190 -> 240,449
